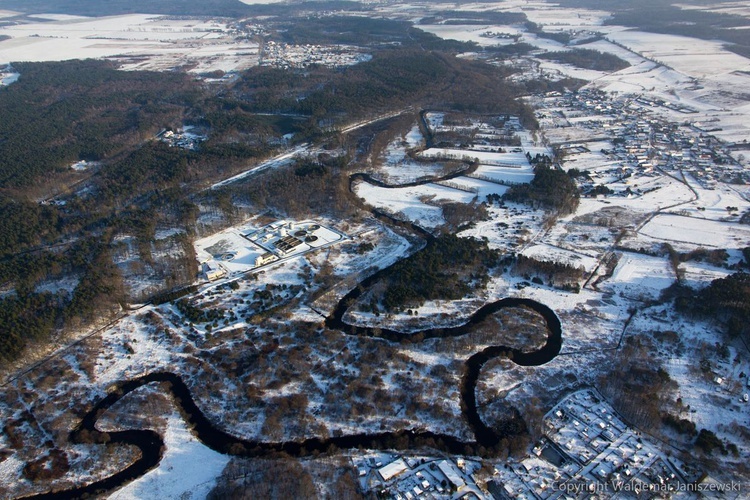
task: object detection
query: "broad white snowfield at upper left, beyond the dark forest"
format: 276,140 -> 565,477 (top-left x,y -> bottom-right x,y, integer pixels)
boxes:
0,14 -> 258,73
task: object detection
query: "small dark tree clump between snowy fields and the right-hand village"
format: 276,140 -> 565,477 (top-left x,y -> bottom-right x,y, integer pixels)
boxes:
503,165 -> 580,215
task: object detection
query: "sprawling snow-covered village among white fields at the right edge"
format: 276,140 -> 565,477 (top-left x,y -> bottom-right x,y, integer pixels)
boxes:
540,89 -> 750,196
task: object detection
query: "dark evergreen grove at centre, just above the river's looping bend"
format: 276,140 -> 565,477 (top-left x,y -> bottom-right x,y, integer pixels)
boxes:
380,234 -> 500,311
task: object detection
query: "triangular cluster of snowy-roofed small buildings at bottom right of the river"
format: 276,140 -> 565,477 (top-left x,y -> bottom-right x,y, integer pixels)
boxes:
488,389 -> 711,500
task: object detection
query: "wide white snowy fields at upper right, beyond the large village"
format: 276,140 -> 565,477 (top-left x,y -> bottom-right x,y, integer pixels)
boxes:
418,1 -> 750,142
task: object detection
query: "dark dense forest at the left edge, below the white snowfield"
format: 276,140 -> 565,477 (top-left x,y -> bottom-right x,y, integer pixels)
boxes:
0,60 -> 199,188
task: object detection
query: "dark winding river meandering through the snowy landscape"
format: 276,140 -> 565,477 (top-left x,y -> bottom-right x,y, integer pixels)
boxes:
25,167 -> 562,498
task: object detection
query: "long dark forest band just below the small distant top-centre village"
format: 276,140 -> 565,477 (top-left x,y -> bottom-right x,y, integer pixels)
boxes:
233,48 -> 538,123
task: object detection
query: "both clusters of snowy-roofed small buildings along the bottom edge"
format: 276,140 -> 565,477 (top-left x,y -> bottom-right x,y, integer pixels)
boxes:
351,388 -> 724,500
